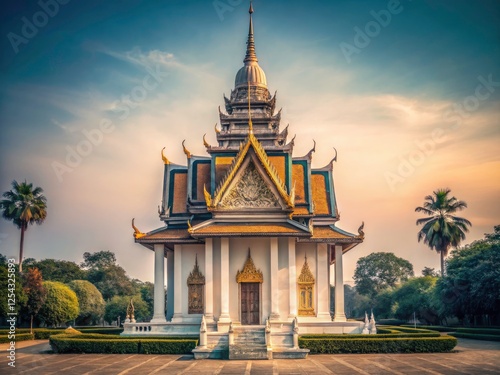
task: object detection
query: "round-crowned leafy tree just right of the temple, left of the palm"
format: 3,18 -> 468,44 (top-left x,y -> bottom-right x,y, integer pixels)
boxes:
353,252 -> 413,297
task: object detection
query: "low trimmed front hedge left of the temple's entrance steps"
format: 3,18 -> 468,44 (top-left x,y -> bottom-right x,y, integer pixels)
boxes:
49,334 -> 198,354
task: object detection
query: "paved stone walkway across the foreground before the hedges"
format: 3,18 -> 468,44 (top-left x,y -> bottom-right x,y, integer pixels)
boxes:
0,339 -> 500,375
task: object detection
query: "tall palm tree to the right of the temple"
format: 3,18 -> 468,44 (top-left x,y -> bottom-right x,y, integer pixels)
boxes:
415,189 -> 472,276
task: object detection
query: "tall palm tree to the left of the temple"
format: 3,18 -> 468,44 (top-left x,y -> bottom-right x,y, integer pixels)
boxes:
0,180 -> 47,272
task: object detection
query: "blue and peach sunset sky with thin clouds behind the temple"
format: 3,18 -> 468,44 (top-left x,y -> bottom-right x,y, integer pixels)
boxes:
0,0 -> 500,283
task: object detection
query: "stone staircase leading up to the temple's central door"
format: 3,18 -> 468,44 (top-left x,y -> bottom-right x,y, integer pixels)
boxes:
229,326 -> 271,359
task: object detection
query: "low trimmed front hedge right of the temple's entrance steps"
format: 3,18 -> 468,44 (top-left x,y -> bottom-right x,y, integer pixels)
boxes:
299,335 -> 457,354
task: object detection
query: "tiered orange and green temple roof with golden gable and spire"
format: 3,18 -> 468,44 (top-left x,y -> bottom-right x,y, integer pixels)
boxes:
134,7 -> 363,251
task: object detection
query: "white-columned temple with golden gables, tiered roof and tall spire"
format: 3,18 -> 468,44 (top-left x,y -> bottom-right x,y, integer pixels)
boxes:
123,6 -> 364,358
